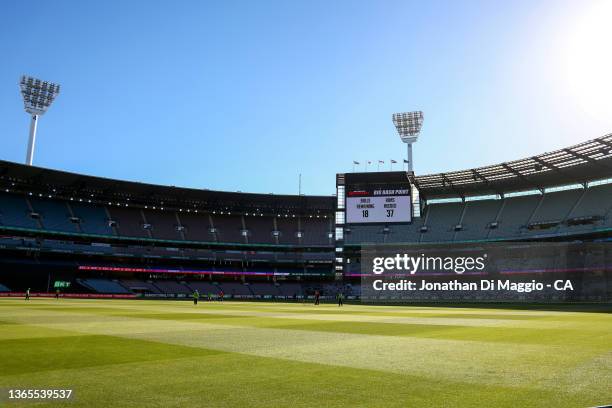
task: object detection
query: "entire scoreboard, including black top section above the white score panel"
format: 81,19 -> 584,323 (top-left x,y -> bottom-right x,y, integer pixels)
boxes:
345,171 -> 412,224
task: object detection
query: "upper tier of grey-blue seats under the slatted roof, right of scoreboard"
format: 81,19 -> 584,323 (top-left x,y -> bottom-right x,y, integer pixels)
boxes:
344,184 -> 612,245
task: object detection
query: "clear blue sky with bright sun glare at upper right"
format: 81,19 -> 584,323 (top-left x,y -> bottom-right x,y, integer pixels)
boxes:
0,0 -> 612,194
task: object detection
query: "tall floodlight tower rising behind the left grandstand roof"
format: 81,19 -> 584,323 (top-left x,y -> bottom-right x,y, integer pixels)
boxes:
19,75 -> 60,166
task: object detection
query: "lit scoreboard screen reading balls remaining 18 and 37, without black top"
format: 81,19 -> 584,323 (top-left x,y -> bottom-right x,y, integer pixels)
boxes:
346,188 -> 412,224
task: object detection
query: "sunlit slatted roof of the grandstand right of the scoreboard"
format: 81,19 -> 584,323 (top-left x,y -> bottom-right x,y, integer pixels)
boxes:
412,134 -> 612,199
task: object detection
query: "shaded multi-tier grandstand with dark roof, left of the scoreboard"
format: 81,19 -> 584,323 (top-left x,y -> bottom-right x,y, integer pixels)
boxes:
0,162 -> 334,298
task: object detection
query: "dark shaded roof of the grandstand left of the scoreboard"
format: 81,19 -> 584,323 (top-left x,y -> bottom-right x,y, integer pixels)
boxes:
0,160 -> 335,214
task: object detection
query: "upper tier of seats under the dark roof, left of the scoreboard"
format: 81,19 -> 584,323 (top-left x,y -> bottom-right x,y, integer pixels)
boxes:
0,193 -> 333,246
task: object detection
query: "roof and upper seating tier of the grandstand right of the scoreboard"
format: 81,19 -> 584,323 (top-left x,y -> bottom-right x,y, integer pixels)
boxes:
343,135 -> 612,246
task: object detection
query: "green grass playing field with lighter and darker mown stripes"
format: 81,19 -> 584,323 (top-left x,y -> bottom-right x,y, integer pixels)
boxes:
0,299 -> 612,407
